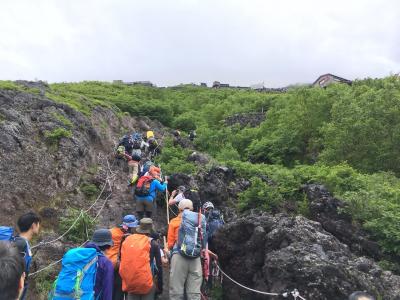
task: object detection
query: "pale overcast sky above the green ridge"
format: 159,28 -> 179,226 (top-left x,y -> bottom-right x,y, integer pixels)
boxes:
0,0 -> 400,87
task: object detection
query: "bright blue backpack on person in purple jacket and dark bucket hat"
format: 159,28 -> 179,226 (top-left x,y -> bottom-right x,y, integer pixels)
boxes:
48,248 -> 102,300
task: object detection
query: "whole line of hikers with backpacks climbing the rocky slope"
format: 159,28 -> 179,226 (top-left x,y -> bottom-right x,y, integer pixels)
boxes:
0,132 -> 374,300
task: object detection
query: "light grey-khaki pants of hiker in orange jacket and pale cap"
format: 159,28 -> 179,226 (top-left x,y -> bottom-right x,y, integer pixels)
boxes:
169,253 -> 203,300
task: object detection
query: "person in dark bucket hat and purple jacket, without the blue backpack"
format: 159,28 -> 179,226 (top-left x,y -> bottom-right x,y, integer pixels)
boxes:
85,229 -> 114,300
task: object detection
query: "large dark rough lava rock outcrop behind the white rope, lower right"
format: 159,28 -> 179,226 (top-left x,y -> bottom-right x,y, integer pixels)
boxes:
216,213 -> 400,300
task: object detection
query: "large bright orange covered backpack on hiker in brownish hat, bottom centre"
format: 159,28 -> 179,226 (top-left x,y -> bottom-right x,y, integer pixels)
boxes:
119,234 -> 153,295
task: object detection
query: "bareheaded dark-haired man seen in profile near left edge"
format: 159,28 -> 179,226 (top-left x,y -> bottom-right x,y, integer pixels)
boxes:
14,212 -> 40,300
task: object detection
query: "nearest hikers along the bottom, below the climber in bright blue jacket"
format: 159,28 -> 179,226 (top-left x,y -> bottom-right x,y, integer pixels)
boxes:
0,198 -> 223,300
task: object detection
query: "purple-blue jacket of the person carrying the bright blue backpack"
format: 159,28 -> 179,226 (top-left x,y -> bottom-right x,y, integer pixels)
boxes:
85,242 -> 114,300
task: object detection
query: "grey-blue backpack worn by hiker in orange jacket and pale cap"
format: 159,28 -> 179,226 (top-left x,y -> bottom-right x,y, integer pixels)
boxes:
178,209 -> 206,258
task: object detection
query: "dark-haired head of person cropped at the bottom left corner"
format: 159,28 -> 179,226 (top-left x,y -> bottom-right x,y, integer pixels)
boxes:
0,241 -> 25,300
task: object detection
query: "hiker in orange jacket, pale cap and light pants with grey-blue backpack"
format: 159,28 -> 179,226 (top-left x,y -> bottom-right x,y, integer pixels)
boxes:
168,199 -> 207,300
